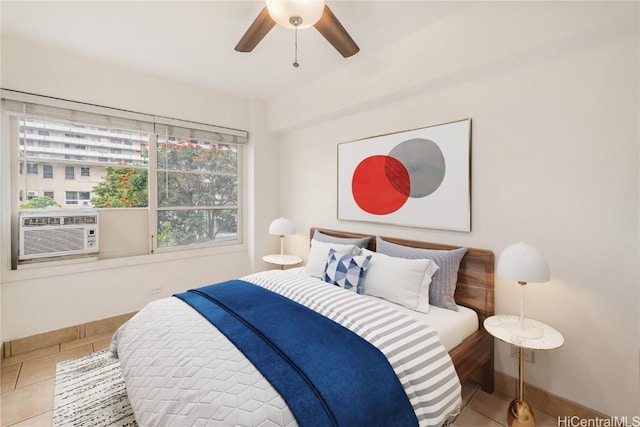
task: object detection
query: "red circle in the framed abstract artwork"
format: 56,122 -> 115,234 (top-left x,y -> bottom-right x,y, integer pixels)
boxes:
351,155 -> 411,215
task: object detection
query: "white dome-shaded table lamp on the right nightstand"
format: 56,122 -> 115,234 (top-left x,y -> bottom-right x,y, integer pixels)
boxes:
496,242 -> 550,339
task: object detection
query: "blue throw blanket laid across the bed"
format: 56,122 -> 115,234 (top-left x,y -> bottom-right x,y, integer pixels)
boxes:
175,280 -> 418,427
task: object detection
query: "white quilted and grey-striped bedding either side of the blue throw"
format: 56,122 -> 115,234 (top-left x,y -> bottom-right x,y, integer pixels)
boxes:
111,270 -> 461,427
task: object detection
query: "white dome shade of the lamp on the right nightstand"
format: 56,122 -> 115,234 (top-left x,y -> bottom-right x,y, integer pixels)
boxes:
497,242 -> 551,283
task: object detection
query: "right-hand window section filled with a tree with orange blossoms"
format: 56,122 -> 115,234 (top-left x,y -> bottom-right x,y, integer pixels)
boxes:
157,135 -> 239,248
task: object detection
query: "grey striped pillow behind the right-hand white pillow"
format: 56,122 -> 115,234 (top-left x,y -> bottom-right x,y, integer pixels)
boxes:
376,236 -> 467,311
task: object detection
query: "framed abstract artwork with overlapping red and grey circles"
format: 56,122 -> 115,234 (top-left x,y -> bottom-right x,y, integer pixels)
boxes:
338,119 -> 471,231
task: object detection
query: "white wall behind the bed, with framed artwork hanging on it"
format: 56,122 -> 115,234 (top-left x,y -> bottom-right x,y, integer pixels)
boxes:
270,2 -> 640,422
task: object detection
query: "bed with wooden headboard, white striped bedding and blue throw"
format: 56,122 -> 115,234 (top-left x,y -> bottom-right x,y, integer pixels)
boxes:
111,228 -> 494,426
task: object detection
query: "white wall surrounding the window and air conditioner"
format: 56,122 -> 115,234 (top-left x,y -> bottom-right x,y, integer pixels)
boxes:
0,37 -> 278,341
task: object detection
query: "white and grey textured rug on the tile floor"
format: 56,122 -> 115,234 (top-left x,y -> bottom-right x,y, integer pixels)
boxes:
53,350 -> 137,427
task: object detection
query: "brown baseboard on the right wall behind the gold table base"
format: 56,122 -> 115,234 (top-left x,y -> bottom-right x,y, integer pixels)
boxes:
495,371 -> 610,420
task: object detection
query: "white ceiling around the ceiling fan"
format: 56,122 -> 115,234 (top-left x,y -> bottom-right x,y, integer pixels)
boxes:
0,0 -> 468,99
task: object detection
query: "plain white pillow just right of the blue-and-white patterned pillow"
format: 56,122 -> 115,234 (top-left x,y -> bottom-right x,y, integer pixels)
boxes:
362,249 -> 438,313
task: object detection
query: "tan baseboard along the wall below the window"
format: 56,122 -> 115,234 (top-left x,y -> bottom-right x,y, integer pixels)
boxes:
2,312 -> 135,359
